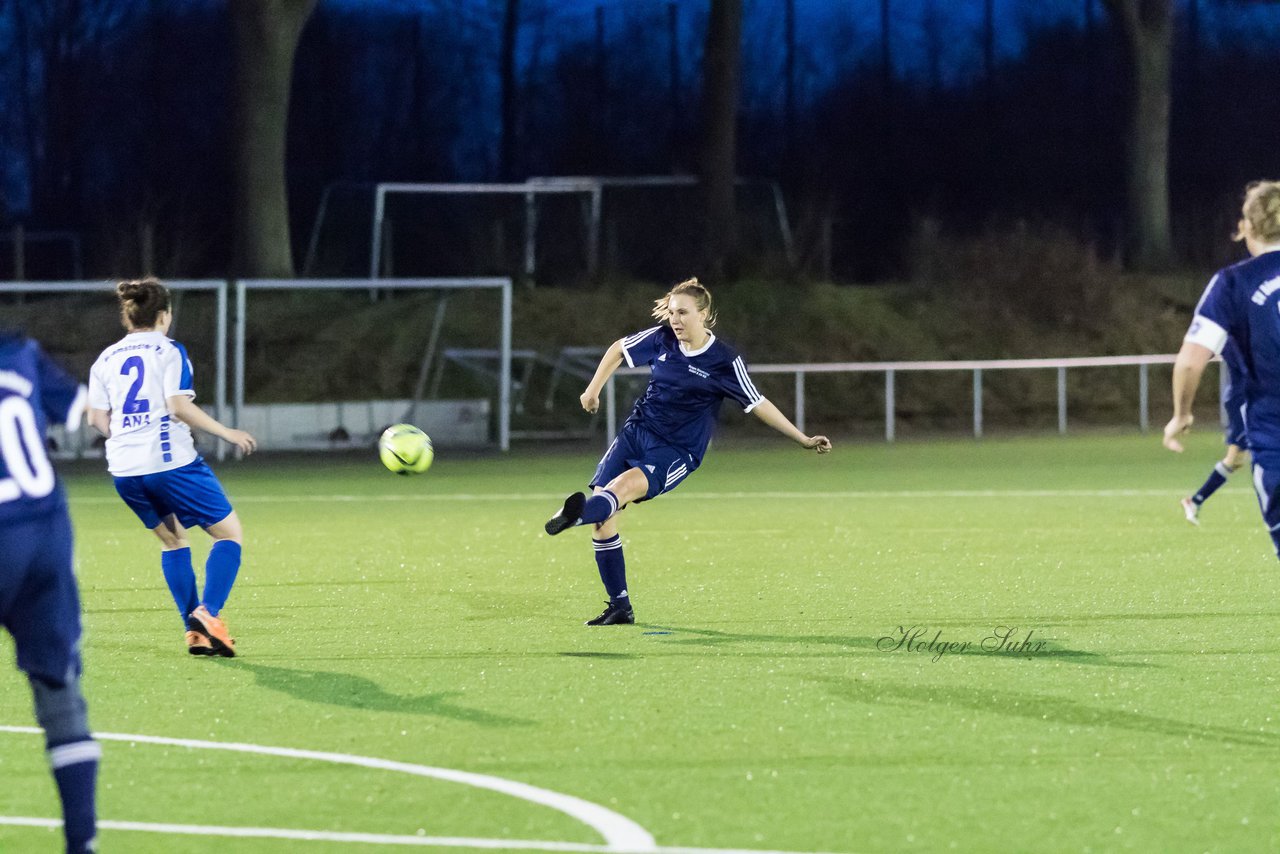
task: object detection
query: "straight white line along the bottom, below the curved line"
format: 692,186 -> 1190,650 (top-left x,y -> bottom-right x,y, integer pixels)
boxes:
0,816 -> 844,854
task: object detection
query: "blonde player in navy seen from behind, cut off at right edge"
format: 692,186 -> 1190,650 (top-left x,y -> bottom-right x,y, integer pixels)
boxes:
1164,181 -> 1280,556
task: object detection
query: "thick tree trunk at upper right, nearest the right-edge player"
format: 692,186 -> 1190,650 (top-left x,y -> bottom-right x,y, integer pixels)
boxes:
1105,0 -> 1174,269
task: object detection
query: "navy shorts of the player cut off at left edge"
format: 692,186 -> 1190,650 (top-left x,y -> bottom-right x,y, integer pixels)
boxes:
0,510 -> 81,688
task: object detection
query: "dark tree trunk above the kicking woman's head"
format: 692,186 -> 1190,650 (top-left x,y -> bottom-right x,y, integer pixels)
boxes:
700,0 -> 742,277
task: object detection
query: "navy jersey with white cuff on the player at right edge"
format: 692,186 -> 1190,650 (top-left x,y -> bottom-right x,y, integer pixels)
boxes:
1187,252 -> 1280,451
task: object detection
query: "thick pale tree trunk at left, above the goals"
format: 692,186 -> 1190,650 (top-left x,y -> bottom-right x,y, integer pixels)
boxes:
230,0 -> 317,278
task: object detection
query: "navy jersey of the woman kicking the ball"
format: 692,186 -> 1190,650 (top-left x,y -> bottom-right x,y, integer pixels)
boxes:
622,326 -> 764,463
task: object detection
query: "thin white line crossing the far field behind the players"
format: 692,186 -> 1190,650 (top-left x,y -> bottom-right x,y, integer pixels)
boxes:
72,488 -> 1218,504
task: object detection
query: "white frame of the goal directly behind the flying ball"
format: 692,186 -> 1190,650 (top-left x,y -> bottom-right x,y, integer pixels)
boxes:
232,277 -> 512,451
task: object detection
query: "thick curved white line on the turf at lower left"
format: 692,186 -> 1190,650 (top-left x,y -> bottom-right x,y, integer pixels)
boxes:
0,726 -> 657,851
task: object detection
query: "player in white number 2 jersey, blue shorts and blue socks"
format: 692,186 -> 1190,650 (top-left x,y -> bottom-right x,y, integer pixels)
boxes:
88,279 -> 257,658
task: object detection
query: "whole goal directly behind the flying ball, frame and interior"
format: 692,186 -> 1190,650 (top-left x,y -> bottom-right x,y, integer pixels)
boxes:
230,278 -> 512,451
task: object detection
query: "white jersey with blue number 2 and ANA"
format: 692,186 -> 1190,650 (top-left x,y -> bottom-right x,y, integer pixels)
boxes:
88,332 -> 198,478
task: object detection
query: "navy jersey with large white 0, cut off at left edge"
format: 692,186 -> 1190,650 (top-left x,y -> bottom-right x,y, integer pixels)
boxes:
0,333 -> 86,525
